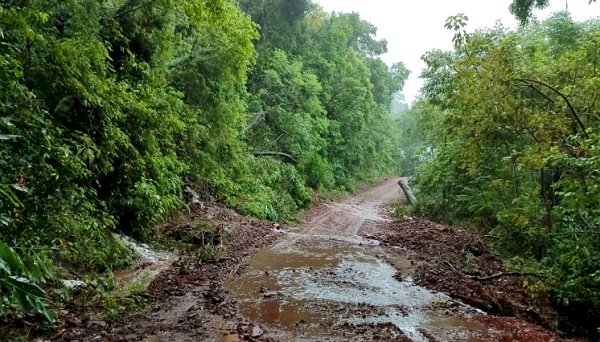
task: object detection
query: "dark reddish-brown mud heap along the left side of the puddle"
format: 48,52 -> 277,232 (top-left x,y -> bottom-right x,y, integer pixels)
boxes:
0,205 -> 282,341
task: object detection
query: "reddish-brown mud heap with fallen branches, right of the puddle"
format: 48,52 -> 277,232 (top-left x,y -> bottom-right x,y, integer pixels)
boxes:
365,218 -> 585,341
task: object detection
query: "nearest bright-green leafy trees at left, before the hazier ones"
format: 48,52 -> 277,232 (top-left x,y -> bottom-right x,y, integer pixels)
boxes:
0,0 -> 257,311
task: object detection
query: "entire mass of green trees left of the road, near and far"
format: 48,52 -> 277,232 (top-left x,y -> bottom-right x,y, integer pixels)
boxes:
0,0 -> 408,317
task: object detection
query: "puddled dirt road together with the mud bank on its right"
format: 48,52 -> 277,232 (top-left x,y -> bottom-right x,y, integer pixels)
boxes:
221,179 -> 572,342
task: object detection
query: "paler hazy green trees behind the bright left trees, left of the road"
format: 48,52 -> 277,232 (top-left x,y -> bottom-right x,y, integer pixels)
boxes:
241,0 -> 408,190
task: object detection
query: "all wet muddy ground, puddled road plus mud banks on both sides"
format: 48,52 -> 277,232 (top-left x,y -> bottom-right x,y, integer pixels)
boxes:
0,179 -> 585,342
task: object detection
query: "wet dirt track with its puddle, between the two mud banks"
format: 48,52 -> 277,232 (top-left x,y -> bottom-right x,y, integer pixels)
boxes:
228,181 -> 490,341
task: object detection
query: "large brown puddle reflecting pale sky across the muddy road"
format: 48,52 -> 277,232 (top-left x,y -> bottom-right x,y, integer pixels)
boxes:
228,236 -> 481,341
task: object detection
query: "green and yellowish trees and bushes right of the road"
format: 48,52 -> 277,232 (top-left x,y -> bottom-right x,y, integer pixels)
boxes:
403,13 -> 600,328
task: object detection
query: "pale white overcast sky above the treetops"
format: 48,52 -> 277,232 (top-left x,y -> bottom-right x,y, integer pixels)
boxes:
315,0 -> 600,103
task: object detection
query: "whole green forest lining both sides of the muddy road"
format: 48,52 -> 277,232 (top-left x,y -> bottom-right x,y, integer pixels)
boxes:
0,0 -> 600,338
